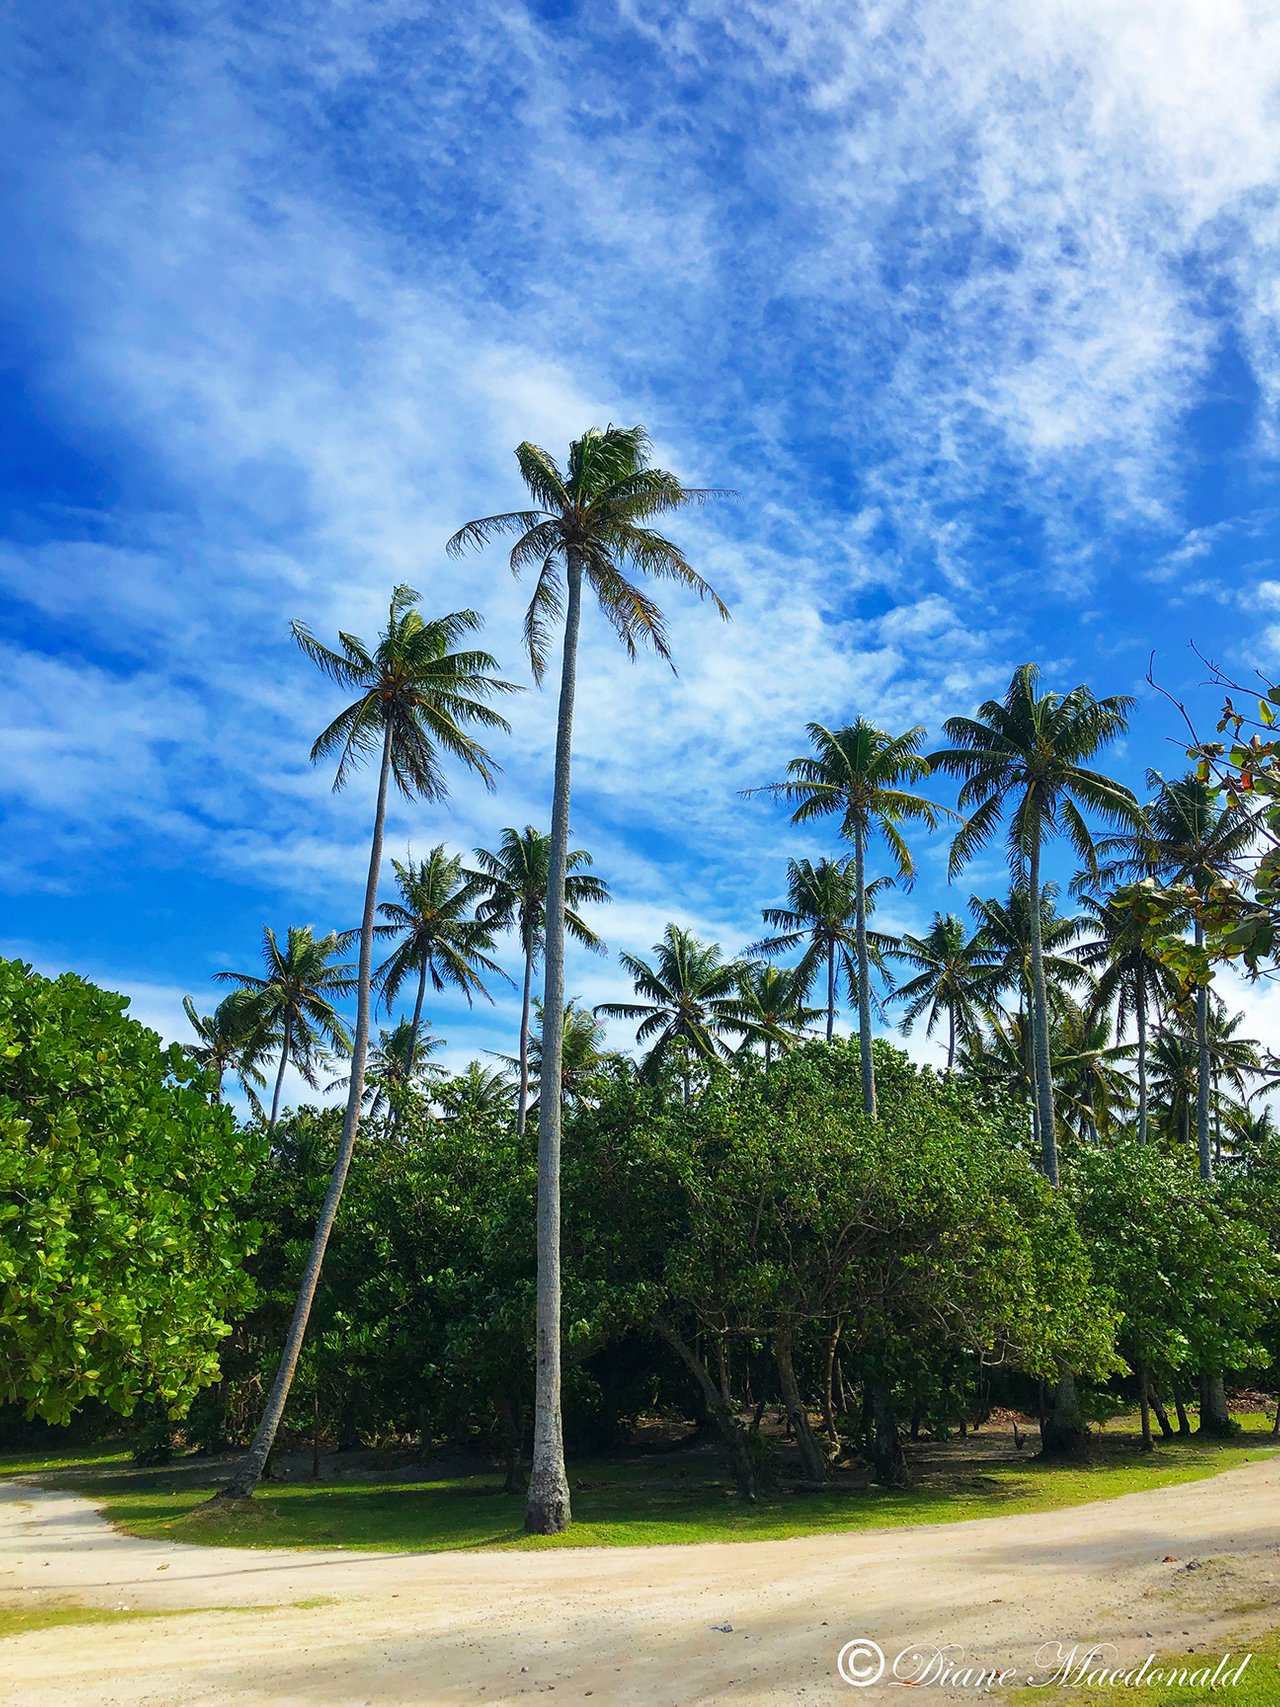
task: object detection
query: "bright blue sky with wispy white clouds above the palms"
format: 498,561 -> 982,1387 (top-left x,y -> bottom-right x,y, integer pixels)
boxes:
0,0 -> 1280,1085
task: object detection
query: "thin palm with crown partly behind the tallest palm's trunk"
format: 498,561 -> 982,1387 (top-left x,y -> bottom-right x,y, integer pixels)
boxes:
473,824 -> 609,1137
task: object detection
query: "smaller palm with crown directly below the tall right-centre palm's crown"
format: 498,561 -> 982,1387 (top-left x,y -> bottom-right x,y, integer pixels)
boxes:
748,859 -> 894,1043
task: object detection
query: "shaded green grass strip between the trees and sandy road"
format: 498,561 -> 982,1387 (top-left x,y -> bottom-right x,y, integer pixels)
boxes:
0,1415 -> 1280,1552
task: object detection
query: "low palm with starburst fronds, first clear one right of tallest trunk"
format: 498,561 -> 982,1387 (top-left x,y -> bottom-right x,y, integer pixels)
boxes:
596,925 -> 753,1103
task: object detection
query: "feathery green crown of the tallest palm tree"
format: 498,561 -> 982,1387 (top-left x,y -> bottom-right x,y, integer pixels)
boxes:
447,427 -> 729,681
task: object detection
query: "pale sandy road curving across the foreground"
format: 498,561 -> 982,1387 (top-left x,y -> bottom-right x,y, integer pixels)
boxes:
0,1459 -> 1280,1707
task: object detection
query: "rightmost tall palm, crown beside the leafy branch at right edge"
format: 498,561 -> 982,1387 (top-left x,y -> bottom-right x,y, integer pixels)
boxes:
1147,770 -> 1256,1180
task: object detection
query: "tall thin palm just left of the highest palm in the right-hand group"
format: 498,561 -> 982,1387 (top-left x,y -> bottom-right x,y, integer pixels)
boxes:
753,717 -> 945,1118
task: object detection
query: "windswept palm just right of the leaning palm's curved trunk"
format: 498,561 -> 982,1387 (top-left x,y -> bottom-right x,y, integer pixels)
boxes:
374,843 -> 507,1067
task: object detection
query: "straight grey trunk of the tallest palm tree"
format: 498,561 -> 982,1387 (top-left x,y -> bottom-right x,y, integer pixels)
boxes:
524,548 -> 582,1535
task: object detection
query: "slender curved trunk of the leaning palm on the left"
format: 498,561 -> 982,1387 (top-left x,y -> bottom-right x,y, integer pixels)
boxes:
215,724 -> 391,1499
